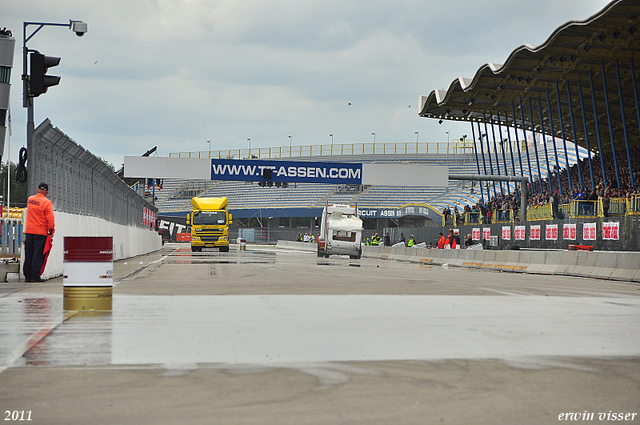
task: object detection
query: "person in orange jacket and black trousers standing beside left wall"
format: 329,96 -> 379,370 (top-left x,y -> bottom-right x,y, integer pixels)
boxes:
22,183 -> 56,282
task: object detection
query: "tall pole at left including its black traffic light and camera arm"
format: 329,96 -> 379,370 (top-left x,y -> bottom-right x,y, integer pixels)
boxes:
22,20 -> 87,196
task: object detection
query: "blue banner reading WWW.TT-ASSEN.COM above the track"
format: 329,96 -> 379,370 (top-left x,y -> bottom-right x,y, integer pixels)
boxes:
211,159 -> 362,184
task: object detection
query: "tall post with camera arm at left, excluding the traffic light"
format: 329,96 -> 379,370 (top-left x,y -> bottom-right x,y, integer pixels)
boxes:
22,20 -> 87,196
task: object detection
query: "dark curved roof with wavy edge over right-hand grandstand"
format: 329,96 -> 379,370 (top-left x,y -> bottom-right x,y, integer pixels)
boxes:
419,0 -> 640,152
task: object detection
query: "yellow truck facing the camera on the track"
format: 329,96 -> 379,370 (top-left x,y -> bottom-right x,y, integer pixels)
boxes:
187,197 -> 232,252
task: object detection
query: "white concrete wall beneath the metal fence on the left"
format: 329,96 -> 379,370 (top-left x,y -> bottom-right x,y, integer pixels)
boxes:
32,211 -> 162,279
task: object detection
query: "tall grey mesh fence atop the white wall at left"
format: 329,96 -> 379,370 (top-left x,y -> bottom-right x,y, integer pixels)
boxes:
28,119 -> 158,228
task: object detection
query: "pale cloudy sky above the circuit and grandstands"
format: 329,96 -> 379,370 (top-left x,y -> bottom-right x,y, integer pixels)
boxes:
0,0 -> 608,168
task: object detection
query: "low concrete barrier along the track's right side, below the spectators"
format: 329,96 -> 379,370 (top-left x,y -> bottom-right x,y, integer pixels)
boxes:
362,246 -> 640,282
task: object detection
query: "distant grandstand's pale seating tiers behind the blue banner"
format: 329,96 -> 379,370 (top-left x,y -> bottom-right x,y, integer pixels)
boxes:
156,142 -> 587,222
